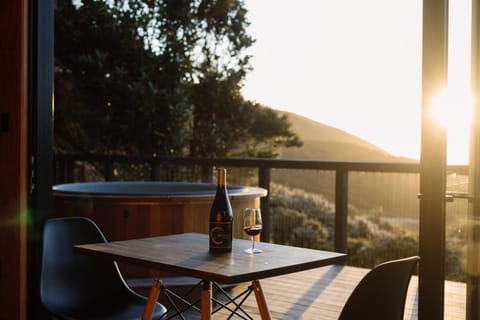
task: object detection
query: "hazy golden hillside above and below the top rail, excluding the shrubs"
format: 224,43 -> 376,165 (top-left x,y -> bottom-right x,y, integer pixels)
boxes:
272,112 -> 419,217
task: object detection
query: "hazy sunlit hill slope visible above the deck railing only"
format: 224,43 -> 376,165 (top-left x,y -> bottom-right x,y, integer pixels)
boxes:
280,111 -> 415,162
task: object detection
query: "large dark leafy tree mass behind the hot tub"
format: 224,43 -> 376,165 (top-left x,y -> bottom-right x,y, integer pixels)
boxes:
54,0 -> 301,157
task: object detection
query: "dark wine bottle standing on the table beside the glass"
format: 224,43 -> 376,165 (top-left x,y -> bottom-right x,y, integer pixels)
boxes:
209,168 -> 233,253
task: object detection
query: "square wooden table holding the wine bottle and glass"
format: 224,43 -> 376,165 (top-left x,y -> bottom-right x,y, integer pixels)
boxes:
74,233 -> 345,319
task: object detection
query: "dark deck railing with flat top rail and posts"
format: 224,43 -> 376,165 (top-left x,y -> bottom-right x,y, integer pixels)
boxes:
55,155 -> 468,252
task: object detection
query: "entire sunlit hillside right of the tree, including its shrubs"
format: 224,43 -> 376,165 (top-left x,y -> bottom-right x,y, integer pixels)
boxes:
270,113 -> 468,281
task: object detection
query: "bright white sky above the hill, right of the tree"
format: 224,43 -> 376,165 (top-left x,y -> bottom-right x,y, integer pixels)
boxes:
243,0 -> 470,163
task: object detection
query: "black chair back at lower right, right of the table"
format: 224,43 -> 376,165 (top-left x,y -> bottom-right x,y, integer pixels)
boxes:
339,256 -> 420,320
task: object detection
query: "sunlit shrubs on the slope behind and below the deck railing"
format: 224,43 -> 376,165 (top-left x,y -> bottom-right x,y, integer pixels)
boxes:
270,185 -> 465,281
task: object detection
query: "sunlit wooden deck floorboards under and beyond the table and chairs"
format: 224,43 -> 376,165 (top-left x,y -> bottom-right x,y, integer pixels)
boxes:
129,265 -> 465,320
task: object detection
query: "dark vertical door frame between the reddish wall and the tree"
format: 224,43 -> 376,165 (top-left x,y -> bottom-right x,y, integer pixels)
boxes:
25,0 -> 54,319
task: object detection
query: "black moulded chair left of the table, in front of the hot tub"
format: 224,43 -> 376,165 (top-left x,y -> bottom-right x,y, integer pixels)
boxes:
40,217 -> 166,320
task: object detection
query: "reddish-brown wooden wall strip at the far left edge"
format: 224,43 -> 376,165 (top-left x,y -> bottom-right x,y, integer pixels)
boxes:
0,0 -> 28,319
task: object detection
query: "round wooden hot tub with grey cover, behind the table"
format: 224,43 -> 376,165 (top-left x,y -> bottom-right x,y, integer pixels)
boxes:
53,181 -> 267,276
